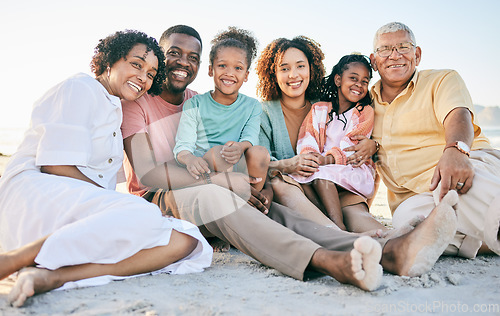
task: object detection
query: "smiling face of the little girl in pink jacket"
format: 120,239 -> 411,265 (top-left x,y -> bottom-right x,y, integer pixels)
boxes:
335,62 -> 370,108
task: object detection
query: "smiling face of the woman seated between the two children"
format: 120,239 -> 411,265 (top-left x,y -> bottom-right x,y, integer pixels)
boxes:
276,47 -> 310,99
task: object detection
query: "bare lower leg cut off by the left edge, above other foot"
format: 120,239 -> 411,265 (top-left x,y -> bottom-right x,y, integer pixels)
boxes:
0,237 -> 47,280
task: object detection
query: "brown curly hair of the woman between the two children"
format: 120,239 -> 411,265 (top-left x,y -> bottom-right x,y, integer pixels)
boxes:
256,36 -> 325,101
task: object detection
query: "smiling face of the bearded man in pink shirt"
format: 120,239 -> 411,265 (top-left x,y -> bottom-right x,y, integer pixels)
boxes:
162,33 -> 201,94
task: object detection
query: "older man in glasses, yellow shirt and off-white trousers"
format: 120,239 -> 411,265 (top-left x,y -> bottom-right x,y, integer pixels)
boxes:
364,22 -> 500,258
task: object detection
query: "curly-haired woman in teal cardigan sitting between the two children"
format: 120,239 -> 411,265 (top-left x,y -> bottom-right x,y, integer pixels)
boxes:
257,36 -> 335,227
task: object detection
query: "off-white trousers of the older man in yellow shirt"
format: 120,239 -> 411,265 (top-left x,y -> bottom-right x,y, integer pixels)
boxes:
392,149 -> 500,258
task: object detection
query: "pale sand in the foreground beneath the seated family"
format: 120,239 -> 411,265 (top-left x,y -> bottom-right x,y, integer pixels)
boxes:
0,156 -> 500,316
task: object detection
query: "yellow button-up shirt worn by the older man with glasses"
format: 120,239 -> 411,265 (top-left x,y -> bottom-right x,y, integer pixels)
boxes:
371,70 -> 491,213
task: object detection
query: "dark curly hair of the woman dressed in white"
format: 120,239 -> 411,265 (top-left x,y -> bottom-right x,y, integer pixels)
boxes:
90,30 -> 166,95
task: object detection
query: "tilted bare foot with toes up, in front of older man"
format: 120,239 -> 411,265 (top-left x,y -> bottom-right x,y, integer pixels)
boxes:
382,190 -> 458,277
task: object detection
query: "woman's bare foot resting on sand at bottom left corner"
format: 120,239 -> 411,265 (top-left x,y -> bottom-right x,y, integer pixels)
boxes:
8,267 -> 62,307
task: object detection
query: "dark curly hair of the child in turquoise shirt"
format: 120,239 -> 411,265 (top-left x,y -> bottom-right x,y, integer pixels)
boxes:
209,26 -> 257,68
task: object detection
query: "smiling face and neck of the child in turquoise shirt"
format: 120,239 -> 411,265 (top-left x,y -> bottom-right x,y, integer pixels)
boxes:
208,47 -> 248,105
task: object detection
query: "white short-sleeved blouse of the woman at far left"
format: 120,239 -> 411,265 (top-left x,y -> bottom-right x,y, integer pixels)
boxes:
1,73 -> 123,189
